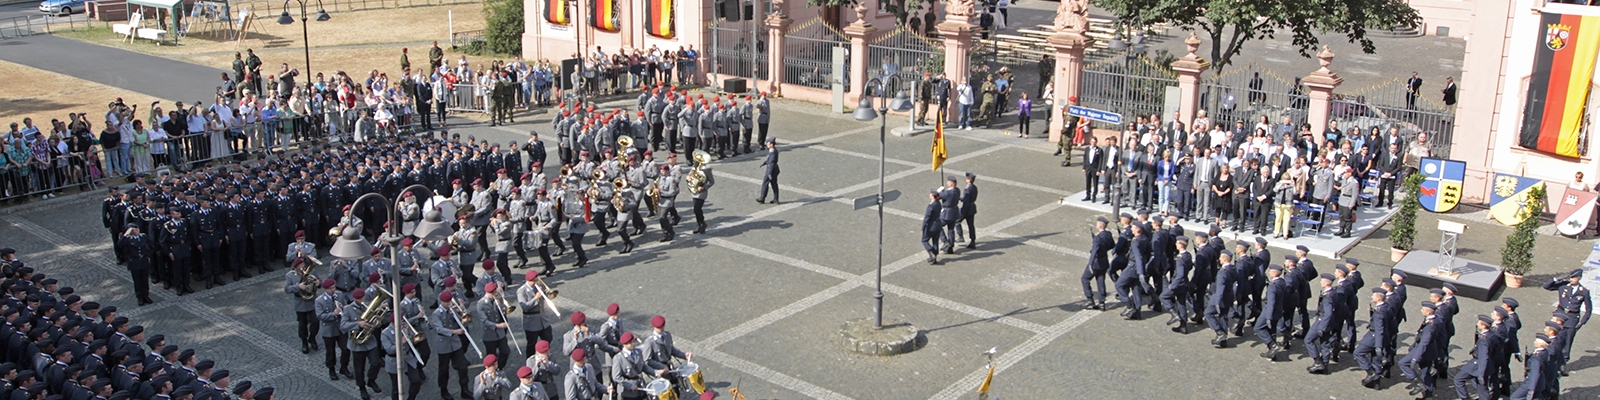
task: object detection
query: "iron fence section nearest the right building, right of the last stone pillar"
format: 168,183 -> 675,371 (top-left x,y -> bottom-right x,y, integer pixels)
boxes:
1330,78 -> 1456,158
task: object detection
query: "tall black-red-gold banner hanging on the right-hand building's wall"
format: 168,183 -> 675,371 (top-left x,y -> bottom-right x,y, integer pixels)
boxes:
1517,13 -> 1600,157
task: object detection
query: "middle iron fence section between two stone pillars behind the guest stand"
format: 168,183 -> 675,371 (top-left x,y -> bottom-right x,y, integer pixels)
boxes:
1203,64 -> 1310,132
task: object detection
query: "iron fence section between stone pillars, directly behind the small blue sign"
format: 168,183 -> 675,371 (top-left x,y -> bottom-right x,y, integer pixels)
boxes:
1078,54 -> 1178,128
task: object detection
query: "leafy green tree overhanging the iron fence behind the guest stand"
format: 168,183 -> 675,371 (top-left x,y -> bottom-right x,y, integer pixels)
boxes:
1093,0 -> 1422,77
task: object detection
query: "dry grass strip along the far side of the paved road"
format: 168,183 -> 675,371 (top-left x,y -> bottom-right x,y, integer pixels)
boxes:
58,3 -> 485,57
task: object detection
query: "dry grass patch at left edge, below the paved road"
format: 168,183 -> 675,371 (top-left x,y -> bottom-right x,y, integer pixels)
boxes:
0,61 -> 157,126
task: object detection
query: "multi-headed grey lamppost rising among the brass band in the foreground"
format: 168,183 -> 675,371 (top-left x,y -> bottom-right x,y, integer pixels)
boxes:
328,184 -> 466,398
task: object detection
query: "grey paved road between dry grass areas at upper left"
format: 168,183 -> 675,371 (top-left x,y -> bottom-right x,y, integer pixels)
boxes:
0,35 -> 224,102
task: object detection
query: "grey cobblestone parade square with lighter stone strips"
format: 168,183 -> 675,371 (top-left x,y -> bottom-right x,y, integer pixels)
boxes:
0,91 -> 1600,398
